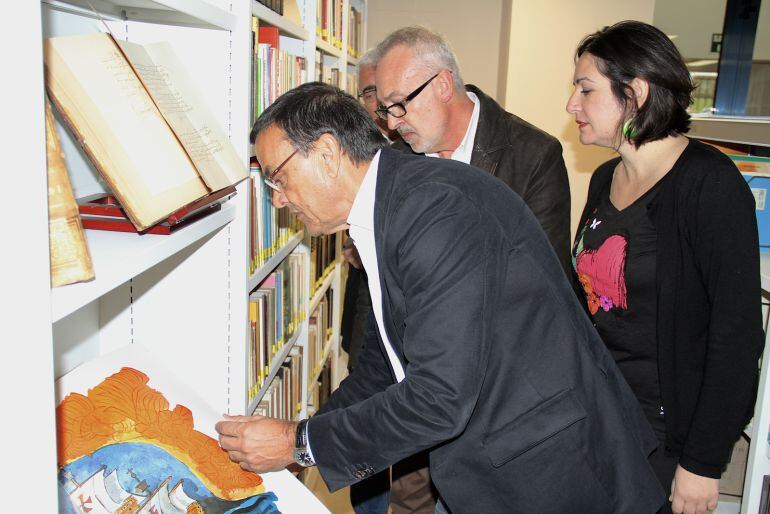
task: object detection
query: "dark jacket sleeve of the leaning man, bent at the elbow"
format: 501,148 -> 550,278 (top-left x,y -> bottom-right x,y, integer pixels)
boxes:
308,183 -> 486,491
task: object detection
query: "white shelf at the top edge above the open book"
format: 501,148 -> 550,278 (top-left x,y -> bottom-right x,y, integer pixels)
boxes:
44,0 -> 237,30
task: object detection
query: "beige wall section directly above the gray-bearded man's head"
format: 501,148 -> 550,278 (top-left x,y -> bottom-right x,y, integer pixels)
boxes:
366,0 -> 503,98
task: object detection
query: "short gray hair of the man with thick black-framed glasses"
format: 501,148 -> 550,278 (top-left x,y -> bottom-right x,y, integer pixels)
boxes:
372,25 -> 465,91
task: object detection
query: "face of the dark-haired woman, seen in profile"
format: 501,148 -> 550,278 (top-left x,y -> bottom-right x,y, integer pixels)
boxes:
567,52 -> 624,148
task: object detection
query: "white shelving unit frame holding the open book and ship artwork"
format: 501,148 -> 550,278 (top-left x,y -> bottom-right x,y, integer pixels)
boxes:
9,0 -> 365,512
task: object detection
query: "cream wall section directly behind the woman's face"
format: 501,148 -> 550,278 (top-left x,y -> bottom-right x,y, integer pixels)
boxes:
505,0 -> 665,234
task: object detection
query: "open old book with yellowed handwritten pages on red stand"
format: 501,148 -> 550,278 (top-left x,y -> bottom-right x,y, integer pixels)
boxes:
44,33 -> 247,231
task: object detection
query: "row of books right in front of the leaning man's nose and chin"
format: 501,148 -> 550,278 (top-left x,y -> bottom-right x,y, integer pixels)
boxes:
249,158 -> 302,273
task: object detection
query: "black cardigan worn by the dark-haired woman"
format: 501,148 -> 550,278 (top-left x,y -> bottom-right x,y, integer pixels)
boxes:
578,139 -> 764,478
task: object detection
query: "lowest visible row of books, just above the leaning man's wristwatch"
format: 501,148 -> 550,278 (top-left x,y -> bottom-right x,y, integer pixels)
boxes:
254,347 -> 302,420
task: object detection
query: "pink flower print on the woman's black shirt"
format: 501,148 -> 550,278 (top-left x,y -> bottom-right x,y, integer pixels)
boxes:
575,235 -> 628,314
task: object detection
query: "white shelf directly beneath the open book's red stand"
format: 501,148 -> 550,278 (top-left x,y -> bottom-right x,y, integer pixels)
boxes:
51,200 -> 235,321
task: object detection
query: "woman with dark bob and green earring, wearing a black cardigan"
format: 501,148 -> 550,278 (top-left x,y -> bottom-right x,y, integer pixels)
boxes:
567,21 -> 763,513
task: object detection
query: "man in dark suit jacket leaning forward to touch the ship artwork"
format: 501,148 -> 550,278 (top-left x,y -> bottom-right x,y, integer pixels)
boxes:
216,83 -> 663,514
